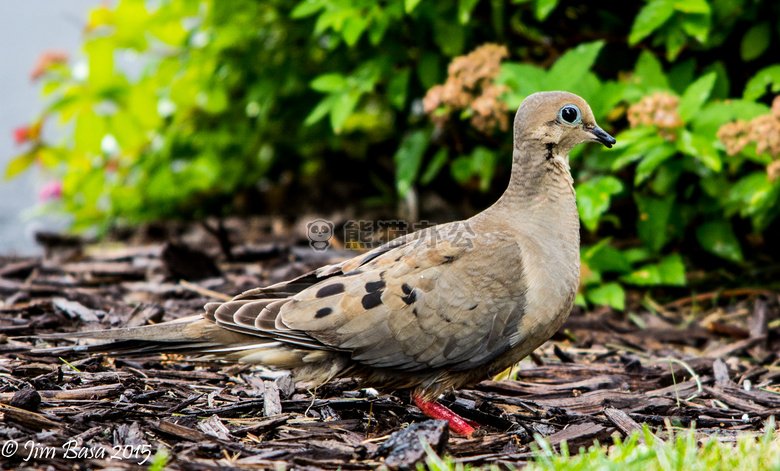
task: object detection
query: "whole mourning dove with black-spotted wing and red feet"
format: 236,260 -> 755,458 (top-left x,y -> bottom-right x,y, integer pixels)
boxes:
38,92 -> 615,435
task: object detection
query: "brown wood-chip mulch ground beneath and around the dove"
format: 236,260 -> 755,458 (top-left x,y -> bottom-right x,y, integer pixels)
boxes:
0,221 -> 780,470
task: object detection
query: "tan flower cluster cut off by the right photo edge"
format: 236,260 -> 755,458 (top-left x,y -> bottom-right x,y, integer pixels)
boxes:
718,95 -> 780,181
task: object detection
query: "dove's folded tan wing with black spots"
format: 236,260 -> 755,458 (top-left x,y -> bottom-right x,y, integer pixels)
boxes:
276,227 -> 525,371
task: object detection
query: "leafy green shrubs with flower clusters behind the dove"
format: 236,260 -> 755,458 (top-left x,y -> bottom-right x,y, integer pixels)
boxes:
6,0 -> 780,309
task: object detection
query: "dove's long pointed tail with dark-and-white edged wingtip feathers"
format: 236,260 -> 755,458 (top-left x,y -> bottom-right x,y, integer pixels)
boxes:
26,269 -> 349,383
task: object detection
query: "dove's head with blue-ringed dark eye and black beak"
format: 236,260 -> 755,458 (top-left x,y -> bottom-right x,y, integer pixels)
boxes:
514,92 -> 615,156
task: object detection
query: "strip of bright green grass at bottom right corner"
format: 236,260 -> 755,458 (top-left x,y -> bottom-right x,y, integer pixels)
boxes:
418,419 -> 780,471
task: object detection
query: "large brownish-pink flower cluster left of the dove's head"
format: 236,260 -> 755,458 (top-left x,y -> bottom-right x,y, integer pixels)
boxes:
423,44 -> 509,134
